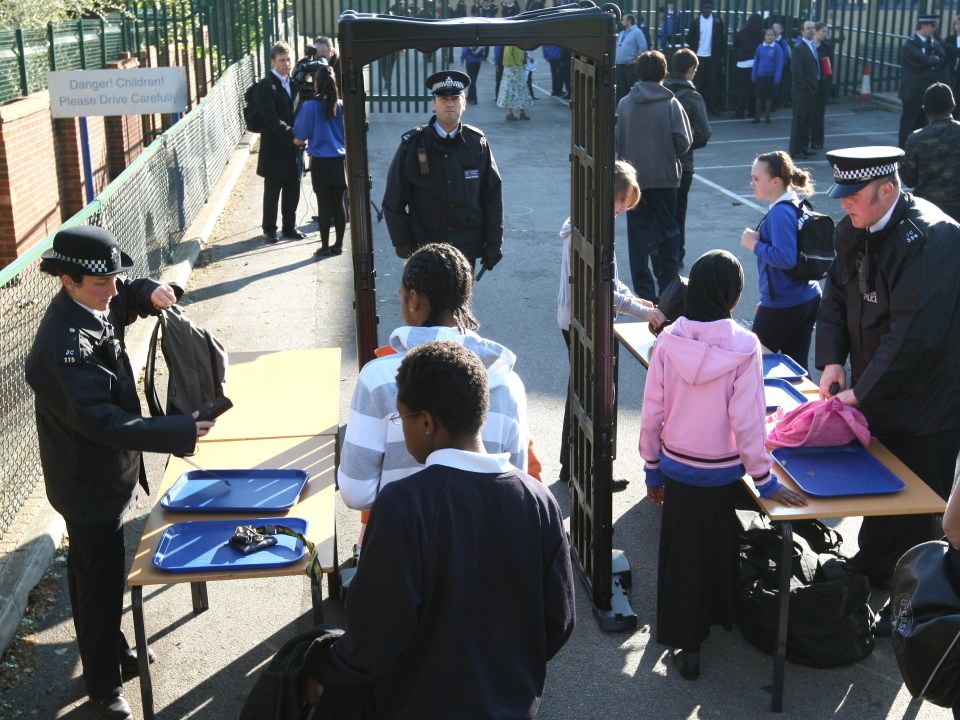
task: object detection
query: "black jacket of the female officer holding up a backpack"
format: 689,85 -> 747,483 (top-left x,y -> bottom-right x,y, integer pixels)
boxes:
26,279 -> 197,525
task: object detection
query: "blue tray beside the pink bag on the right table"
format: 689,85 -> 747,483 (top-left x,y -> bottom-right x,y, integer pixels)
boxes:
771,445 -> 906,497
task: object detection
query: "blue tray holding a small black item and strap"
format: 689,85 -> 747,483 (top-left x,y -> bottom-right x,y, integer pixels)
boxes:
153,517 -> 307,572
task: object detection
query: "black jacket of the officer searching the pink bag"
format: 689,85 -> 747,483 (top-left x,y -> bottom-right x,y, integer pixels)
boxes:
816,193 -> 960,438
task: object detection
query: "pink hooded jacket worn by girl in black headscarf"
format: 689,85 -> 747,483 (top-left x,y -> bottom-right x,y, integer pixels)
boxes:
640,317 -> 774,489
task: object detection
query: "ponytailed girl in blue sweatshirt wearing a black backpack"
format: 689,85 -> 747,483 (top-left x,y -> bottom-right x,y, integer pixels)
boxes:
740,150 -> 821,369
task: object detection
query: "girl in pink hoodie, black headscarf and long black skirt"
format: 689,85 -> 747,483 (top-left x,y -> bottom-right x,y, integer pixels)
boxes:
640,250 -> 806,680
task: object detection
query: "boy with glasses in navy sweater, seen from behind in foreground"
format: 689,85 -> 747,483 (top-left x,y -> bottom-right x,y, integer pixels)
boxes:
302,342 -> 575,720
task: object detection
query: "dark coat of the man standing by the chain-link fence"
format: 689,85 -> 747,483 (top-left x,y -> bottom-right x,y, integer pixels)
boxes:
254,72 -> 300,182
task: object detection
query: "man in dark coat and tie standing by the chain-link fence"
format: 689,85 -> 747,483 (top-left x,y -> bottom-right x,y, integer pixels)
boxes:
255,42 -> 306,243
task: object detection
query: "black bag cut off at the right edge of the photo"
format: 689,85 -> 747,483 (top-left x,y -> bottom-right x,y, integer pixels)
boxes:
890,541 -> 960,708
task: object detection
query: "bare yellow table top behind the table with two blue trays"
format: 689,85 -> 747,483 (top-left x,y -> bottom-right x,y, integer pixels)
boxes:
200,348 -> 340,444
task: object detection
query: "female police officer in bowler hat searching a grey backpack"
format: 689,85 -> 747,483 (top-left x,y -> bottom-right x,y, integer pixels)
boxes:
25,226 -> 213,720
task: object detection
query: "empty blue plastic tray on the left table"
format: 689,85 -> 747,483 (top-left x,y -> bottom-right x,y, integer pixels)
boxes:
160,469 -> 307,512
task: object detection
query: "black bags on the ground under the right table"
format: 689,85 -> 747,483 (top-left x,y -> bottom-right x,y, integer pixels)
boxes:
737,510 -> 874,667
